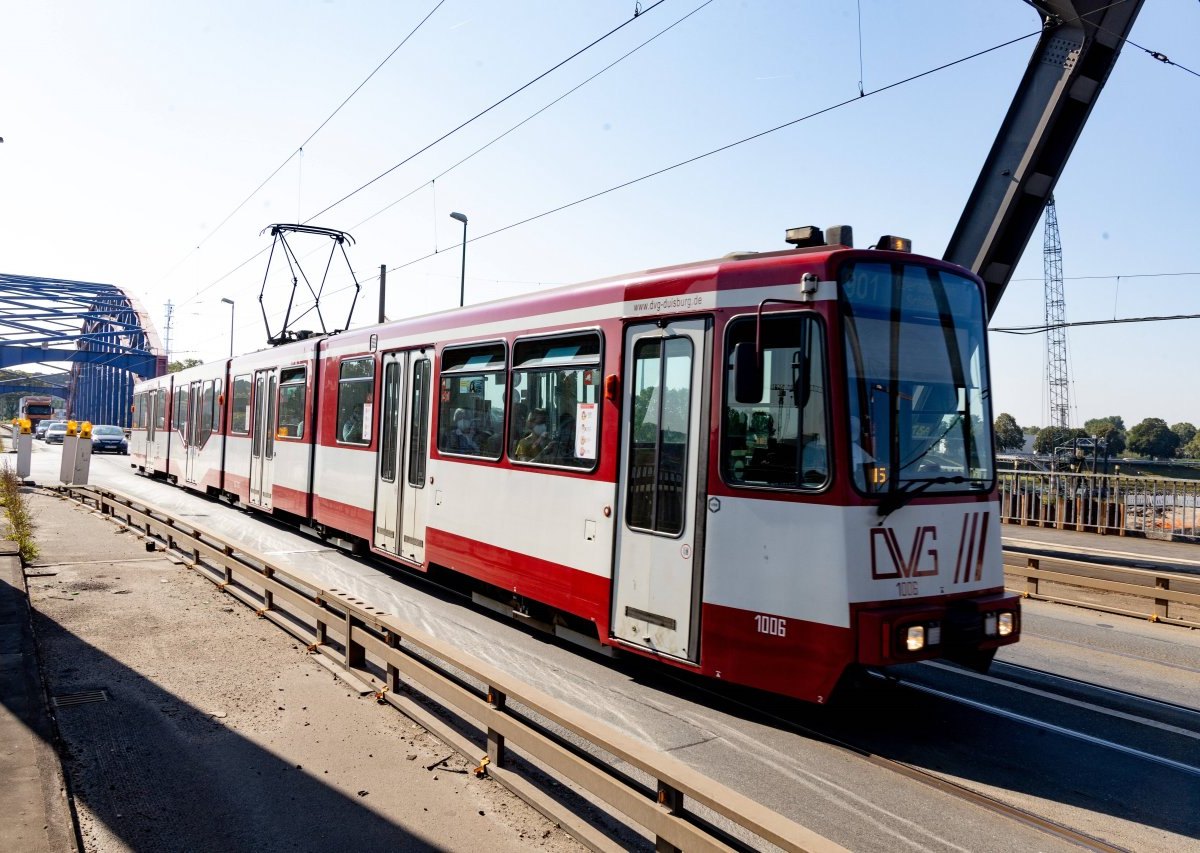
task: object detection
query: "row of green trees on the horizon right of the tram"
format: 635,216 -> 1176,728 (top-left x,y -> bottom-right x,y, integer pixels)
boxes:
995,413 -> 1200,459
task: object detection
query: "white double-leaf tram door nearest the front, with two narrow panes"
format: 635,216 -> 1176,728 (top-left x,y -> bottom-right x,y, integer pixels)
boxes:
373,352 -> 431,564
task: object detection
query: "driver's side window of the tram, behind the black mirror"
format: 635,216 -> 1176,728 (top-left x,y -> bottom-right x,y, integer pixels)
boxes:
721,313 -> 829,489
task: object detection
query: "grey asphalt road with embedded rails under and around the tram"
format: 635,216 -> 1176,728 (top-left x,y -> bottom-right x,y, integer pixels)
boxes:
18,443 -> 1200,852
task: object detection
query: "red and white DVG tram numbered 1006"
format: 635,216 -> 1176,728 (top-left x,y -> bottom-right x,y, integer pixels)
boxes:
131,228 -> 1020,702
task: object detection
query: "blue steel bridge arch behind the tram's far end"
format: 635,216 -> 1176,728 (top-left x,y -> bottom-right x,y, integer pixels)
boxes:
0,272 -> 167,427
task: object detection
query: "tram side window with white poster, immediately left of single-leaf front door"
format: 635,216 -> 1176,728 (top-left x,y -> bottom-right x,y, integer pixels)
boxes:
509,332 -> 601,469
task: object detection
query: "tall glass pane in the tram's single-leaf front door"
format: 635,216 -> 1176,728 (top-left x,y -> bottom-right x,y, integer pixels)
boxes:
626,337 -> 692,536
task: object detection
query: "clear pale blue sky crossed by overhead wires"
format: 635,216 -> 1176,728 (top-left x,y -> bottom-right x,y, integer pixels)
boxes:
0,0 -> 1200,434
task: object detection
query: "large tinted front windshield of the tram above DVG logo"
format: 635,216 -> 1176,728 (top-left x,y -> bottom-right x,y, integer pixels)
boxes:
839,263 -> 995,509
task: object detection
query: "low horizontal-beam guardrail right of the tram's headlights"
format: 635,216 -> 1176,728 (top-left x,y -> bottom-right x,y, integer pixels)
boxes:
1004,551 -> 1200,627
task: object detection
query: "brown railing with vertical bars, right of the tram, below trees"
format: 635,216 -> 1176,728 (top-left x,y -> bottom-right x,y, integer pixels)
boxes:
998,471 -> 1200,542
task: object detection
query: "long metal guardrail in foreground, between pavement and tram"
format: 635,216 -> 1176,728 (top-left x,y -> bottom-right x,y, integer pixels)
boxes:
62,486 -> 844,853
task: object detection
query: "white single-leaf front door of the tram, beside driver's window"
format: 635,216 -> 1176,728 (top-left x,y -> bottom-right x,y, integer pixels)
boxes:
612,319 -> 710,661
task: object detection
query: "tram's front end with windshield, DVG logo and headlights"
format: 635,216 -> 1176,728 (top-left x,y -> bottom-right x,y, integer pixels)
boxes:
838,252 -> 1020,669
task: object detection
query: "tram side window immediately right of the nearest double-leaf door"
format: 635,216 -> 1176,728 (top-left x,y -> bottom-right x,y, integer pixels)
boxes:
438,343 -> 504,459
